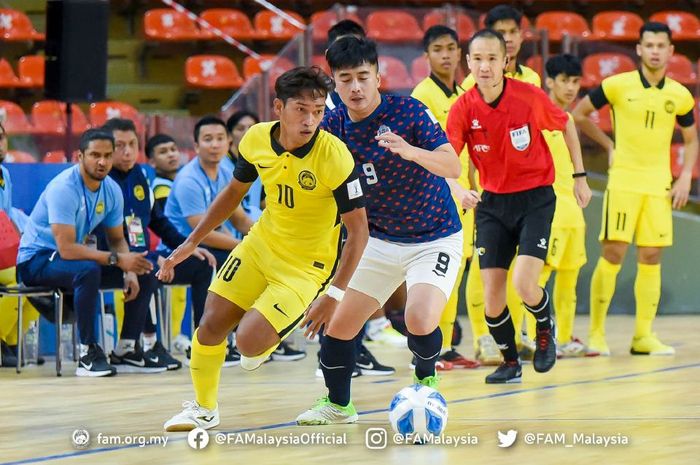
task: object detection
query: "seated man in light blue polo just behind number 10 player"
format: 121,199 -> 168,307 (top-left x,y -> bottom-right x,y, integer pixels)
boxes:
165,116 -> 253,266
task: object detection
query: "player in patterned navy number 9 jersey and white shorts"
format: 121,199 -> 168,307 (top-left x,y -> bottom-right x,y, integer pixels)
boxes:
297,37 -> 478,425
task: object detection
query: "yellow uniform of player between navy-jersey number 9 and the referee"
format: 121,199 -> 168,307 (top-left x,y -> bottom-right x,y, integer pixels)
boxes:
411,74 -> 474,348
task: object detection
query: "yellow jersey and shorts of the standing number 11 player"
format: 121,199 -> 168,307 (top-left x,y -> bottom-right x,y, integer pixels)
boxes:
600,71 -> 695,247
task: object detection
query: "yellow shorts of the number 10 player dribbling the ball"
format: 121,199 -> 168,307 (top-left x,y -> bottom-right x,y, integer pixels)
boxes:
209,235 -> 330,339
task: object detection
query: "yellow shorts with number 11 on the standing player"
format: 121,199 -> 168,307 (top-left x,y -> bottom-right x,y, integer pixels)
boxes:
598,190 -> 673,247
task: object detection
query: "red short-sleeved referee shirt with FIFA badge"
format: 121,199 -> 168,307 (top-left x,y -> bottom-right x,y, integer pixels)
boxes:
447,78 -> 568,194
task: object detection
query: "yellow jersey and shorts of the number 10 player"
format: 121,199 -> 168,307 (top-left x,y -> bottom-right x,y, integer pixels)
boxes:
209,121 -> 361,340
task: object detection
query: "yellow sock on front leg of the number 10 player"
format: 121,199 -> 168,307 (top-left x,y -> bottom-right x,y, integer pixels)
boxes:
190,329 -> 226,409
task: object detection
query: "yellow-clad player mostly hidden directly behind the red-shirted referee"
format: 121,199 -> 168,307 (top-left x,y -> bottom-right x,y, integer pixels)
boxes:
460,5 -> 542,365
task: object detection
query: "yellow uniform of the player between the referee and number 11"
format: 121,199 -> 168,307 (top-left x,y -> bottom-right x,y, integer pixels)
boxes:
540,115 -> 586,345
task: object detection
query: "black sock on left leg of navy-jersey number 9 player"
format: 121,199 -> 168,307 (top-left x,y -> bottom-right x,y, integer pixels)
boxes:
321,335 -> 355,407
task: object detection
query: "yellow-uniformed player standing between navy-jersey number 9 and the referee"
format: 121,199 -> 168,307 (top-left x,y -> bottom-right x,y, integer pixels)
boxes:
411,25 -> 480,369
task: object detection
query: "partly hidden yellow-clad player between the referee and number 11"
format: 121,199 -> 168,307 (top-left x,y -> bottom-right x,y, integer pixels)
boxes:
539,54 -> 598,357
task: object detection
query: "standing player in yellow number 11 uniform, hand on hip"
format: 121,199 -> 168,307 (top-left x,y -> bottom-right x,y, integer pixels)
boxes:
573,22 -> 698,355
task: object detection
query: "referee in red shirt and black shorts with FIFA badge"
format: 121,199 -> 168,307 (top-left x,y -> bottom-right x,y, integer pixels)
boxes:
447,29 -> 591,384
